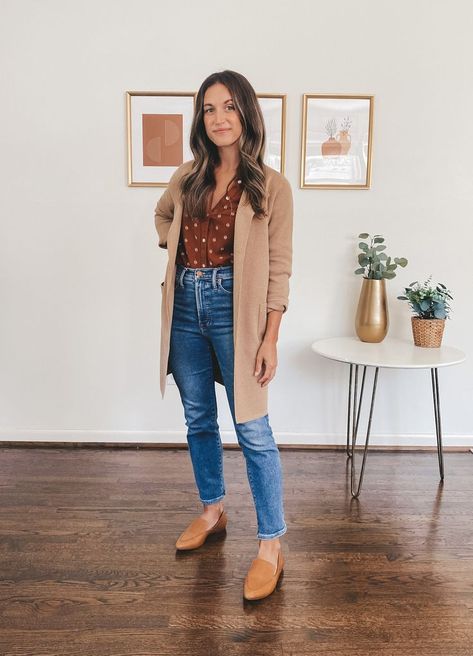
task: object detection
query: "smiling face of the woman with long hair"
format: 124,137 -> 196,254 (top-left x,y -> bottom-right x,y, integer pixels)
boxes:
204,82 -> 243,148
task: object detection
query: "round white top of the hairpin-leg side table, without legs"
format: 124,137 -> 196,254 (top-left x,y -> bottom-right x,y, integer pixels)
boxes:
312,337 -> 466,369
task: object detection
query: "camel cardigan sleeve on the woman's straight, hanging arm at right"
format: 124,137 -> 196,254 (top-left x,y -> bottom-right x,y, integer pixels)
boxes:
267,177 -> 293,312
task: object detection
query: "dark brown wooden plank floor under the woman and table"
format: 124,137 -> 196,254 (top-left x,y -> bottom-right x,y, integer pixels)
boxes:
0,448 -> 473,656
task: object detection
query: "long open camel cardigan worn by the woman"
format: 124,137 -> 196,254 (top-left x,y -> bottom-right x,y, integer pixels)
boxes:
155,160 -> 293,423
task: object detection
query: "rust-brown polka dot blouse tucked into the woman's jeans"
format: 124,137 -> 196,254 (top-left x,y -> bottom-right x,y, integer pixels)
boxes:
176,178 -> 242,269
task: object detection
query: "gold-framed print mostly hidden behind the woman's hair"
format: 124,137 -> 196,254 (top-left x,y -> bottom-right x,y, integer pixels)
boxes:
257,93 -> 286,174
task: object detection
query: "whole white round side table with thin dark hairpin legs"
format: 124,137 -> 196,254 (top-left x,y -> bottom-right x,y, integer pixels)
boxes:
312,337 -> 465,497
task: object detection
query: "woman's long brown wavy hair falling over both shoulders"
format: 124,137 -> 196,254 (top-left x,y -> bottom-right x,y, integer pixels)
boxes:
180,70 -> 266,219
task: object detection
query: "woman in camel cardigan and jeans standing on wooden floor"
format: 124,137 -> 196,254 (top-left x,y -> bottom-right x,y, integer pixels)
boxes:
155,70 -> 292,599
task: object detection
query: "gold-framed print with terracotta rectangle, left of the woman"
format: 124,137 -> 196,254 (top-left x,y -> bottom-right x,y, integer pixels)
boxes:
126,91 -> 195,187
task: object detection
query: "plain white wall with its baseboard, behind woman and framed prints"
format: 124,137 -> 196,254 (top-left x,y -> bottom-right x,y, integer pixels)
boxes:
0,0 -> 473,445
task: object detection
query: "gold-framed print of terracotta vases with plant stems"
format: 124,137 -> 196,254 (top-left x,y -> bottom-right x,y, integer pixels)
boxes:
301,94 -> 374,189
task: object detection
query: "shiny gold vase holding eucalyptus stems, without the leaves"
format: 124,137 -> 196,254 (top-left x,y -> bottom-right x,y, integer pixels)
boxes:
355,278 -> 389,342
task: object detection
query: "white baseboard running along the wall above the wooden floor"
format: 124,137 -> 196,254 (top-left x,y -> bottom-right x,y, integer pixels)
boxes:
0,429 -> 473,452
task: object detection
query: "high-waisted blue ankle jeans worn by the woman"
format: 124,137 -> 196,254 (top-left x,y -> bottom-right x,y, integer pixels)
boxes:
169,264 -> 287,540
